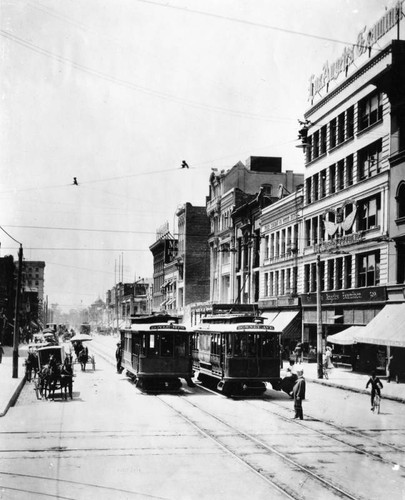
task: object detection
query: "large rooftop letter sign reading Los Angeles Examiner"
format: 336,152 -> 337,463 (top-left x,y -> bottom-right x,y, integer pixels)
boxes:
308,0 -> 405,100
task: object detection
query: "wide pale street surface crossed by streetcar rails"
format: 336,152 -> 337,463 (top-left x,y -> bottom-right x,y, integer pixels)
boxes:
0,339 -> 405,500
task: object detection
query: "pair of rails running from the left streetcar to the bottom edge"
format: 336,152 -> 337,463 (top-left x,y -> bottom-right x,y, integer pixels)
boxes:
157,395 -> 361,500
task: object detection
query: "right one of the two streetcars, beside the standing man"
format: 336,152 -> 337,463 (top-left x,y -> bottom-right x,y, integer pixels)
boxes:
192,307 -> 281,396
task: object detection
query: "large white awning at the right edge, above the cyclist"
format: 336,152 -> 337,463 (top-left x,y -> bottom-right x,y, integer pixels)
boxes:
354,303 -> 405,347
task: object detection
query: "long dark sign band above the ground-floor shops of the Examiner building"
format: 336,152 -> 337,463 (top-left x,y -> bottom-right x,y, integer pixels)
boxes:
301,286 -> 387,307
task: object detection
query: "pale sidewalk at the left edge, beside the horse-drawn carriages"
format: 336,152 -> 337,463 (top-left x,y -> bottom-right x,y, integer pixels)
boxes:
0,345 -> 27,417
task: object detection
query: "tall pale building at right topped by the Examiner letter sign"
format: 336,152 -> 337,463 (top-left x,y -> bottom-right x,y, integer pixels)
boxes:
298,2 -> 405,370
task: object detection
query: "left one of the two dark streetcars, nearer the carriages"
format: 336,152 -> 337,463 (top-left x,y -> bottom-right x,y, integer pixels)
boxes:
120,315 -> 194,391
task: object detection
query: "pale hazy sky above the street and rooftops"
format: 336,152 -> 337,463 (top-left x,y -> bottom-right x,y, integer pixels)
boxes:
0,0 -> 393,312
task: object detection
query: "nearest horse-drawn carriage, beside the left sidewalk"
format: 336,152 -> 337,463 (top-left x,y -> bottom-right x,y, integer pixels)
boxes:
34,346 -> 73,400
